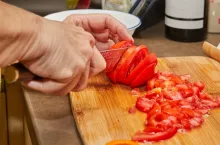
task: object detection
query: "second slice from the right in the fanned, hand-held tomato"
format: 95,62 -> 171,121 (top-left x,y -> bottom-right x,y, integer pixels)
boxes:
126,53 -> 157,84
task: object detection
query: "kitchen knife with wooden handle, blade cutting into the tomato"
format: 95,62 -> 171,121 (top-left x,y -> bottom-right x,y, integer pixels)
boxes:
3,48 -> 127,84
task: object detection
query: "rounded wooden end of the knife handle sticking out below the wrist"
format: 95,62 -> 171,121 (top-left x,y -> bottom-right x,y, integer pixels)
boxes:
4,63 -> 41,84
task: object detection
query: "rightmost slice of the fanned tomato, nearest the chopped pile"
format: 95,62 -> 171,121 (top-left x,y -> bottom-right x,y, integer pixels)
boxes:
131,63 -> 157,88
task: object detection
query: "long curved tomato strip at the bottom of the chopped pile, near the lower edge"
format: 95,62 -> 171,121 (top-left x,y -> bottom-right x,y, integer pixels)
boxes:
132,127 -> 177,142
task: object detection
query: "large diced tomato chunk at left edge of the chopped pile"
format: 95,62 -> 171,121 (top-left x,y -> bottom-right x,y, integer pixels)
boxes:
136,97 -> 155,112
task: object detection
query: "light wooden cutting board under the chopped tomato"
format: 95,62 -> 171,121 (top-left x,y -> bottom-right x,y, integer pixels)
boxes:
70,56 -> 220,145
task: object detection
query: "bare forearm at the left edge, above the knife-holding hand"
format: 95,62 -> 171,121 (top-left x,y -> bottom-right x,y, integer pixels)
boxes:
0,1 -> 42,67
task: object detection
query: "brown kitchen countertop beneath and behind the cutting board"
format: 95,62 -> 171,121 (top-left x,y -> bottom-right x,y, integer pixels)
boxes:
24,23 -> 220,145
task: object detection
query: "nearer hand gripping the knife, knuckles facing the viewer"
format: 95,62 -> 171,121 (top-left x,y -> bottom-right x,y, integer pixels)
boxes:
19,20 -> 106,95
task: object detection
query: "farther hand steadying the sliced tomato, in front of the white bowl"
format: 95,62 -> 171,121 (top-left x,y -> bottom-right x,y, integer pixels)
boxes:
64,14 -> 133,50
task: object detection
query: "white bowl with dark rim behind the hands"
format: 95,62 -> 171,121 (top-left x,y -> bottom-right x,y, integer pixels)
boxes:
45,9 -> 141,35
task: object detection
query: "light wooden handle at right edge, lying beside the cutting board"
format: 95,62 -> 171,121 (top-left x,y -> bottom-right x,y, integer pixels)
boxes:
202,41 -> 220,62
